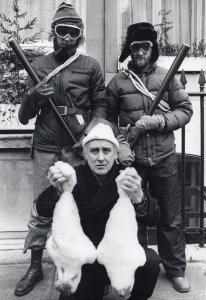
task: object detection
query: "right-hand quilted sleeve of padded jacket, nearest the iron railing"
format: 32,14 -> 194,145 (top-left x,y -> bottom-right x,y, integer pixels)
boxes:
164,77 -> 193,132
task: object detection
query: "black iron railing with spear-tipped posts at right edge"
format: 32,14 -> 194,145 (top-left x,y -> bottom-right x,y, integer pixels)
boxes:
180,70 -> 206,247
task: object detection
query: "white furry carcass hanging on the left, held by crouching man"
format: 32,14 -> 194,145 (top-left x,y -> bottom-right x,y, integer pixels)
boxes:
47,161 -> 96,294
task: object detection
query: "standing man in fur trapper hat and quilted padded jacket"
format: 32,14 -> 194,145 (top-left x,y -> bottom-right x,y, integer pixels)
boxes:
107,22 -> 193,292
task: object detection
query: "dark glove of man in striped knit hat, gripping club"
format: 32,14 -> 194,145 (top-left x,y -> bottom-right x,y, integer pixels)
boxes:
28,82 -> 54,107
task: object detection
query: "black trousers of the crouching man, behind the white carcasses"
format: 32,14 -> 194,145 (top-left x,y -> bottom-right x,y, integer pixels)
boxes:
59,248 -> 160,300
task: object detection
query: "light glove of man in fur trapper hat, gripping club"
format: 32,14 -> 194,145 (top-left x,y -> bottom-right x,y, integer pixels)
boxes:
135,115 -> 165,131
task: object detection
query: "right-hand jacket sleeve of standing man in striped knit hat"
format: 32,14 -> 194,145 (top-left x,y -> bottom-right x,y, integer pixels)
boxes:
90,61 -> 108,119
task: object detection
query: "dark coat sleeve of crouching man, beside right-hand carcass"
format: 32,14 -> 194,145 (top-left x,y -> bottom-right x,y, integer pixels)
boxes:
133,190 -> 160,226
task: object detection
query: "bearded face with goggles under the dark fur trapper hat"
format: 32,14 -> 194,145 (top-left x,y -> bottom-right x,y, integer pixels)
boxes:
131,41 -> 152,69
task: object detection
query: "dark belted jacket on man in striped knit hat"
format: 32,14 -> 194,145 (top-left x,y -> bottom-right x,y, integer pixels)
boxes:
19,52 -> 108,152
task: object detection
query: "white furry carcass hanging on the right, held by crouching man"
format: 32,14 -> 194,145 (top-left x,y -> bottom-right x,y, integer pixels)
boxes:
97,168 -> 146,299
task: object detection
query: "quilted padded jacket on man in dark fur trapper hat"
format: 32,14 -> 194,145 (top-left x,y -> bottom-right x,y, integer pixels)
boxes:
107,62 -> 193,166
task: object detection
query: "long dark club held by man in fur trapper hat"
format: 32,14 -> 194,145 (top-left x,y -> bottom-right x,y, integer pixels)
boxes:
131,44 -> 190,150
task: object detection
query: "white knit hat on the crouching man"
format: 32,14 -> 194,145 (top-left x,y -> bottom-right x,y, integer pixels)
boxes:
82,123 -> 119,149
